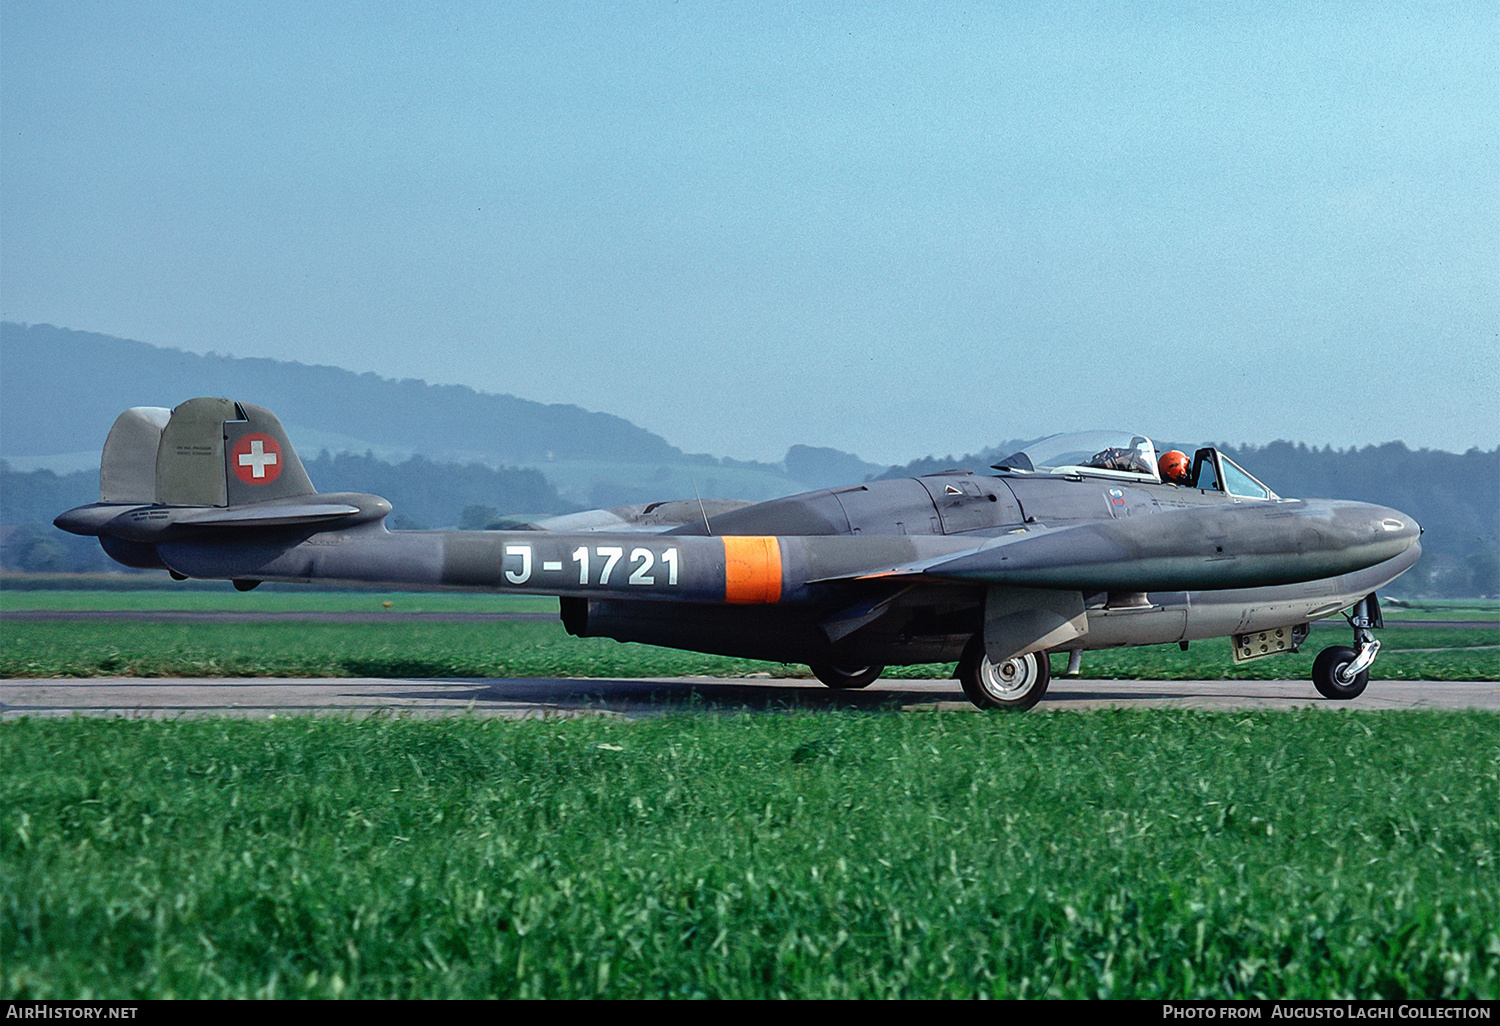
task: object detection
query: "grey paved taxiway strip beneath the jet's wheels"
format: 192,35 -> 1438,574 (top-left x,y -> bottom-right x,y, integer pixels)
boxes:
0,677 -> 1500,720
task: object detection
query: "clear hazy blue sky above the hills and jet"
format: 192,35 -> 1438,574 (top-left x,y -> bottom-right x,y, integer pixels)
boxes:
0,0 -> 1500,462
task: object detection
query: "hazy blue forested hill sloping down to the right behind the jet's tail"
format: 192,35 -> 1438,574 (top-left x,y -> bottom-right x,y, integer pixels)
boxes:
0,323 -> 683,465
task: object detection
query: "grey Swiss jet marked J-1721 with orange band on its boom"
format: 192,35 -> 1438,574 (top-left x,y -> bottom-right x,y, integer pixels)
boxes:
56,398 -> 1422,710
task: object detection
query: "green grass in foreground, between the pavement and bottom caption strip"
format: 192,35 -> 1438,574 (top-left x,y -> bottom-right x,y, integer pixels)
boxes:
0,711 -> 1500,999
